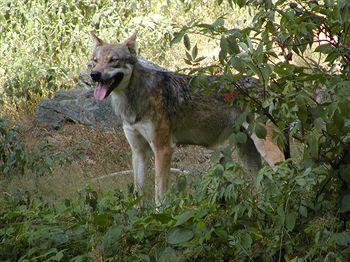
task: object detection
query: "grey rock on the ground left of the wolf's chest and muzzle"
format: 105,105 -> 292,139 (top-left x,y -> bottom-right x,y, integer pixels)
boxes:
35,70 -> 121,129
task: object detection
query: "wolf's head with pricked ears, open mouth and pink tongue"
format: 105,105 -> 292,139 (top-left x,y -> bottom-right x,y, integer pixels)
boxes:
91,33 -> 137,101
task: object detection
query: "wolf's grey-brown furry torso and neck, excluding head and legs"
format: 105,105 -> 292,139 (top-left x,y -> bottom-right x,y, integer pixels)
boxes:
116,61 -> 242,147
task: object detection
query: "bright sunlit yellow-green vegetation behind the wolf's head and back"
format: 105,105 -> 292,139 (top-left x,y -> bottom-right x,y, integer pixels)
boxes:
0,0 -> 252,111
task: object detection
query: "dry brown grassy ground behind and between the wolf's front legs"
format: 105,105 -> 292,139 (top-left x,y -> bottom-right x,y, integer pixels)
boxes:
0,117 -> 211,203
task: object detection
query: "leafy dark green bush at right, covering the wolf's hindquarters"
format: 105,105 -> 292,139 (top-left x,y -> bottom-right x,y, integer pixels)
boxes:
178,0 -> 350,216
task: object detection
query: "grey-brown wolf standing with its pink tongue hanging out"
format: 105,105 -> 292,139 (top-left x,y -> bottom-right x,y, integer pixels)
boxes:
91,33 -> 283,206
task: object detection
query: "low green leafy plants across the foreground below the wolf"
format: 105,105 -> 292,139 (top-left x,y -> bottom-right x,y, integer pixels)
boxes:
0,159 -> 350,261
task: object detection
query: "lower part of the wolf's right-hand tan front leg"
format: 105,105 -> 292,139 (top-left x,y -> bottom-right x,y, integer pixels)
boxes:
155,145 -> 174,207
